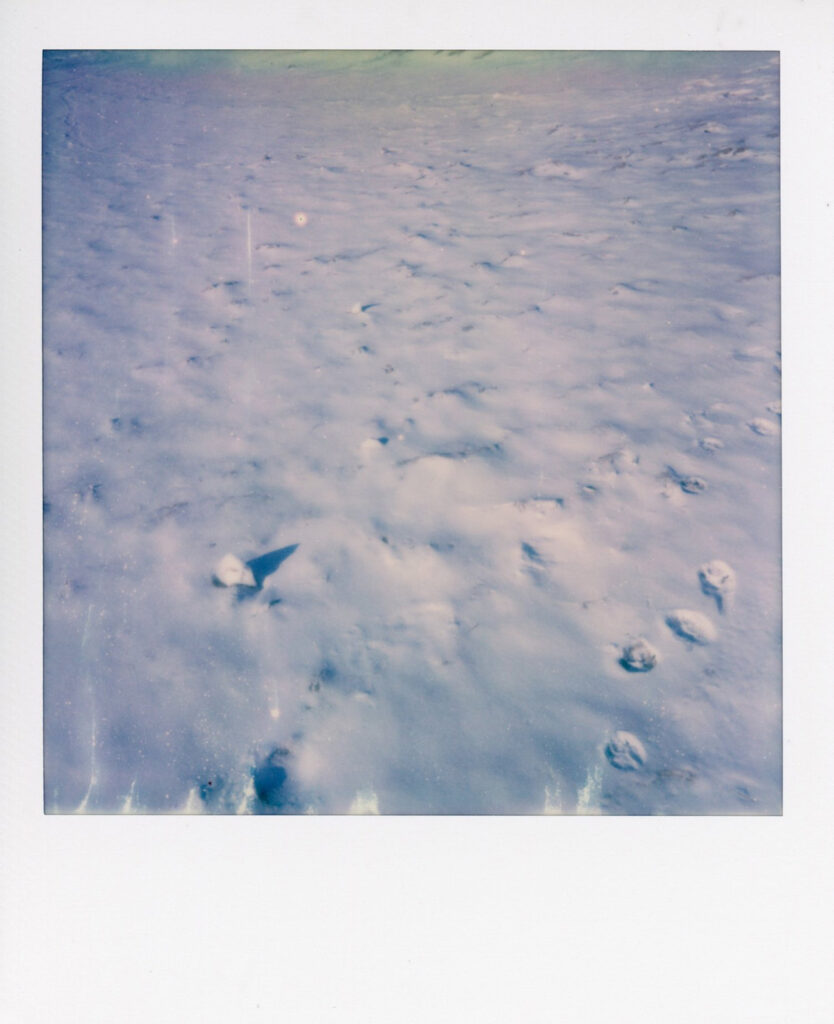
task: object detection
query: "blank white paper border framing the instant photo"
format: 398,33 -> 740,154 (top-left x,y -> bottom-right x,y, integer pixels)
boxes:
0,0 -> 834,1024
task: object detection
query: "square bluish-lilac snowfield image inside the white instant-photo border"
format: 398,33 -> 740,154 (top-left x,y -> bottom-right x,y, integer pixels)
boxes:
43,51 -> 781,814
